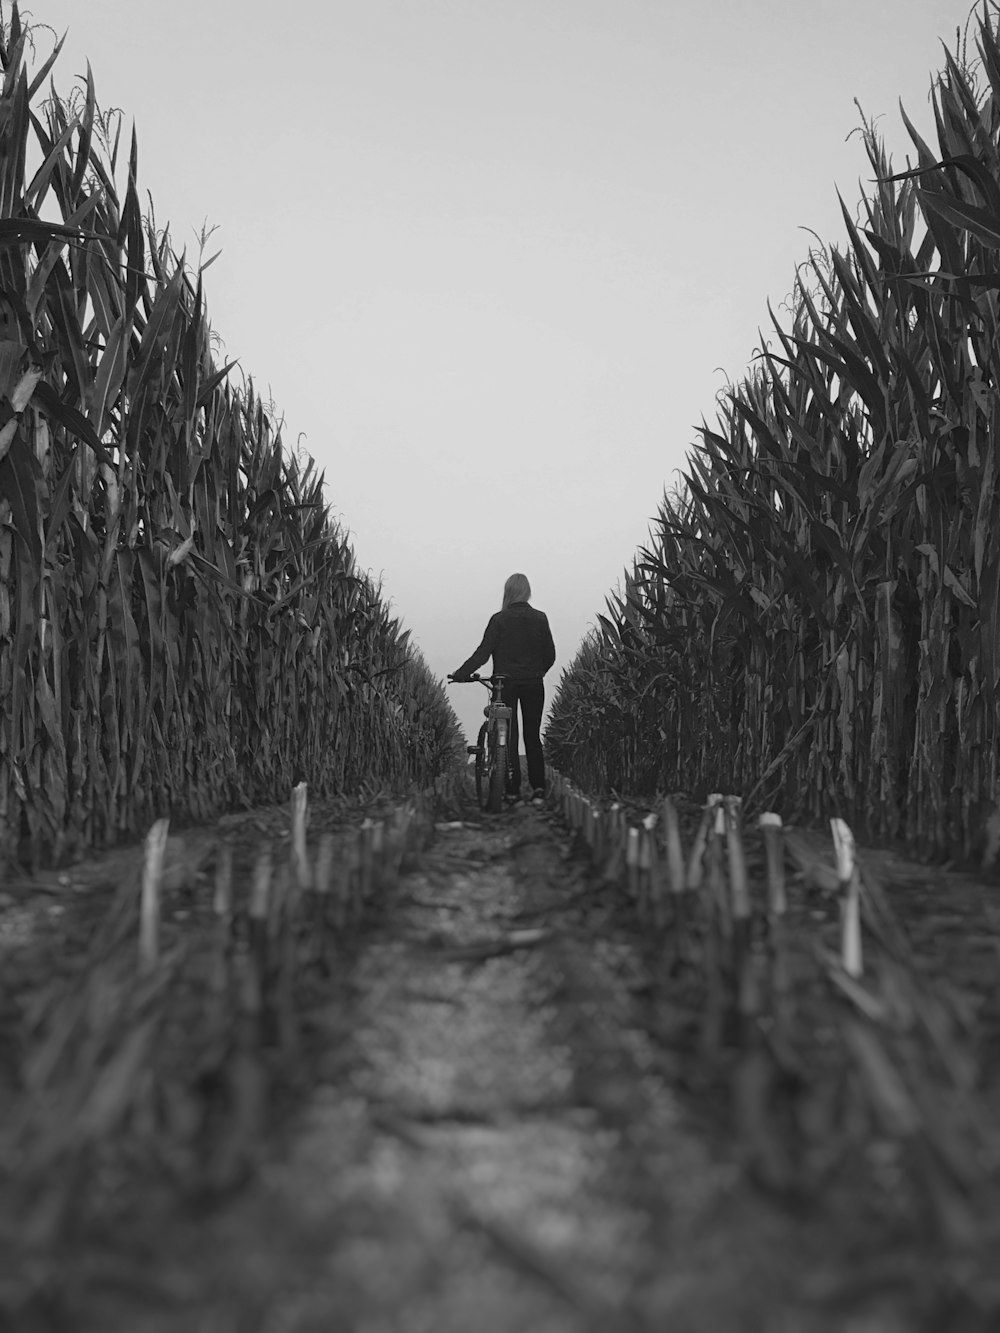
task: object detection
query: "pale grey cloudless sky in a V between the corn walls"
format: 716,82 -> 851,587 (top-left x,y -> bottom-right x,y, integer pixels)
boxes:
13,0 -> 971,738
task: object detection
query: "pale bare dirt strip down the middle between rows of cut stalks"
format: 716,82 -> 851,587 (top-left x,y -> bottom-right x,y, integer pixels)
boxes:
289,812 -> 709,1330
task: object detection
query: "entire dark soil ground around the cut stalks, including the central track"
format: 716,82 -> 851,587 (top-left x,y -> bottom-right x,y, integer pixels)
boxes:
0,783 -> 1000,1333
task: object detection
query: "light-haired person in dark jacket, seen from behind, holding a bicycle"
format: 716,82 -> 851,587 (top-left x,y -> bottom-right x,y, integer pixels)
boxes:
452,575 -> 556,804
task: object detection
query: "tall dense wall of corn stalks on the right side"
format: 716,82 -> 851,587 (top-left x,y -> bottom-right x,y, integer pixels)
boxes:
547,9 -> 1000,856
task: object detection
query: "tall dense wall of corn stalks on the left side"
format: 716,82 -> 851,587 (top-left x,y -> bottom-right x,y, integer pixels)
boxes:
0,5 -> 461,865
